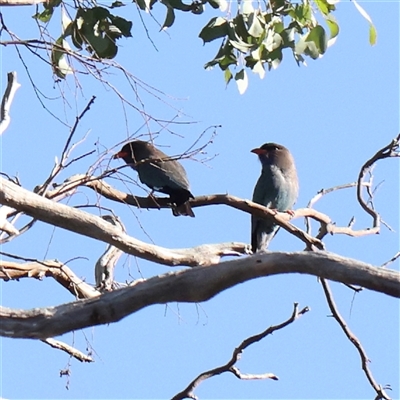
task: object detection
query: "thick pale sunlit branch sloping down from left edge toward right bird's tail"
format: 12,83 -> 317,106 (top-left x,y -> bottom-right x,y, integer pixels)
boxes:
0,178 -> 249,266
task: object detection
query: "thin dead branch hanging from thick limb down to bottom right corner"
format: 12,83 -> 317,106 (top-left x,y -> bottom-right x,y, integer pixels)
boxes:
321,279 -> 390,400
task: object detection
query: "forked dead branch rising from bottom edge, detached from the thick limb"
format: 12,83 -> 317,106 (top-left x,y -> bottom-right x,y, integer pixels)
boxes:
172,303 -> 309,400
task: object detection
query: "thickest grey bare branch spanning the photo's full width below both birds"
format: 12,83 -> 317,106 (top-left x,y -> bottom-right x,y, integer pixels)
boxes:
0,252 -> 400,339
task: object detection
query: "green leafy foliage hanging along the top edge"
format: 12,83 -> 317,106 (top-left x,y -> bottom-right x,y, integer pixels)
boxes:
28,0 -> 376,93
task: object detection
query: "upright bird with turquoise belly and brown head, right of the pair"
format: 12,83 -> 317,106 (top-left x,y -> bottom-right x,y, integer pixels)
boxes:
251,143 -> 299,253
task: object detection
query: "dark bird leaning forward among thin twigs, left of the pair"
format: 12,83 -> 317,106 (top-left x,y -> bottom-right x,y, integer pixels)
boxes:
113,140 -> 195,217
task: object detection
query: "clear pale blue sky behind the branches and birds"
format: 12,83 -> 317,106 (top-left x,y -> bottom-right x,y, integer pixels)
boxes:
0,2 -> 400,399
